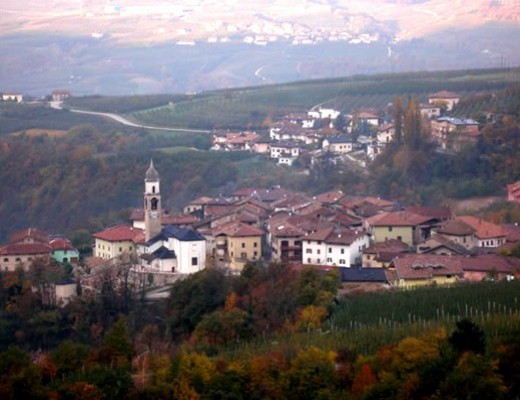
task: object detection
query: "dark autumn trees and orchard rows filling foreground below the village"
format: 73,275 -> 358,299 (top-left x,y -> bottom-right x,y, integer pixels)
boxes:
0,264 -> 520,400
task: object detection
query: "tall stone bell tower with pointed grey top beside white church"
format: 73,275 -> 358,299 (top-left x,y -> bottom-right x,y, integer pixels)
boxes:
144,160 -> 162,241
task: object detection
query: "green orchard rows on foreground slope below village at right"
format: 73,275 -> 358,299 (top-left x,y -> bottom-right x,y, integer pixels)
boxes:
224,282 -> 520,358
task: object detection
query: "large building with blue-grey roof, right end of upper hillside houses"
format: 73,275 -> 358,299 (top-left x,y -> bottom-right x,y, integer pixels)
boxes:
431,117 -> 479,151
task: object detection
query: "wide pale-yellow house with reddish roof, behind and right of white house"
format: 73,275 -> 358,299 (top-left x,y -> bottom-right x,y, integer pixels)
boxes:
365,211 -> 438,246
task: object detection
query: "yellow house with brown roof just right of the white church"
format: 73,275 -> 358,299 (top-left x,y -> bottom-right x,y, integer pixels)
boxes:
214,221 -> 264,271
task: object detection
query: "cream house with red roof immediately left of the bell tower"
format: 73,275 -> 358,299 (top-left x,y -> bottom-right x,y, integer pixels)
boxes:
92,225 -> 143,260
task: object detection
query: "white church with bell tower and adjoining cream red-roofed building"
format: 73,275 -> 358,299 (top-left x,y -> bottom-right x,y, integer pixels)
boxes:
93,160 -> 206,274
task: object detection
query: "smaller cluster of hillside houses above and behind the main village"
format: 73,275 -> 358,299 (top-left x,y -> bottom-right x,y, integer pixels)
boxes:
212,91 -> 479,165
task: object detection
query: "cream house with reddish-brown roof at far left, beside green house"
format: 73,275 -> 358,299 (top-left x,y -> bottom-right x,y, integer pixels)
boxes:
0,242 -> 52,271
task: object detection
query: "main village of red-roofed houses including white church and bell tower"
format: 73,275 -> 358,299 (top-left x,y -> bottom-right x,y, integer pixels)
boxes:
0,162 -> 520,298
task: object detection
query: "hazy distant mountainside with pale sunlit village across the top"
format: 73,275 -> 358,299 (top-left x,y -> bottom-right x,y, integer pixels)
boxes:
0,0 -> 520,95
